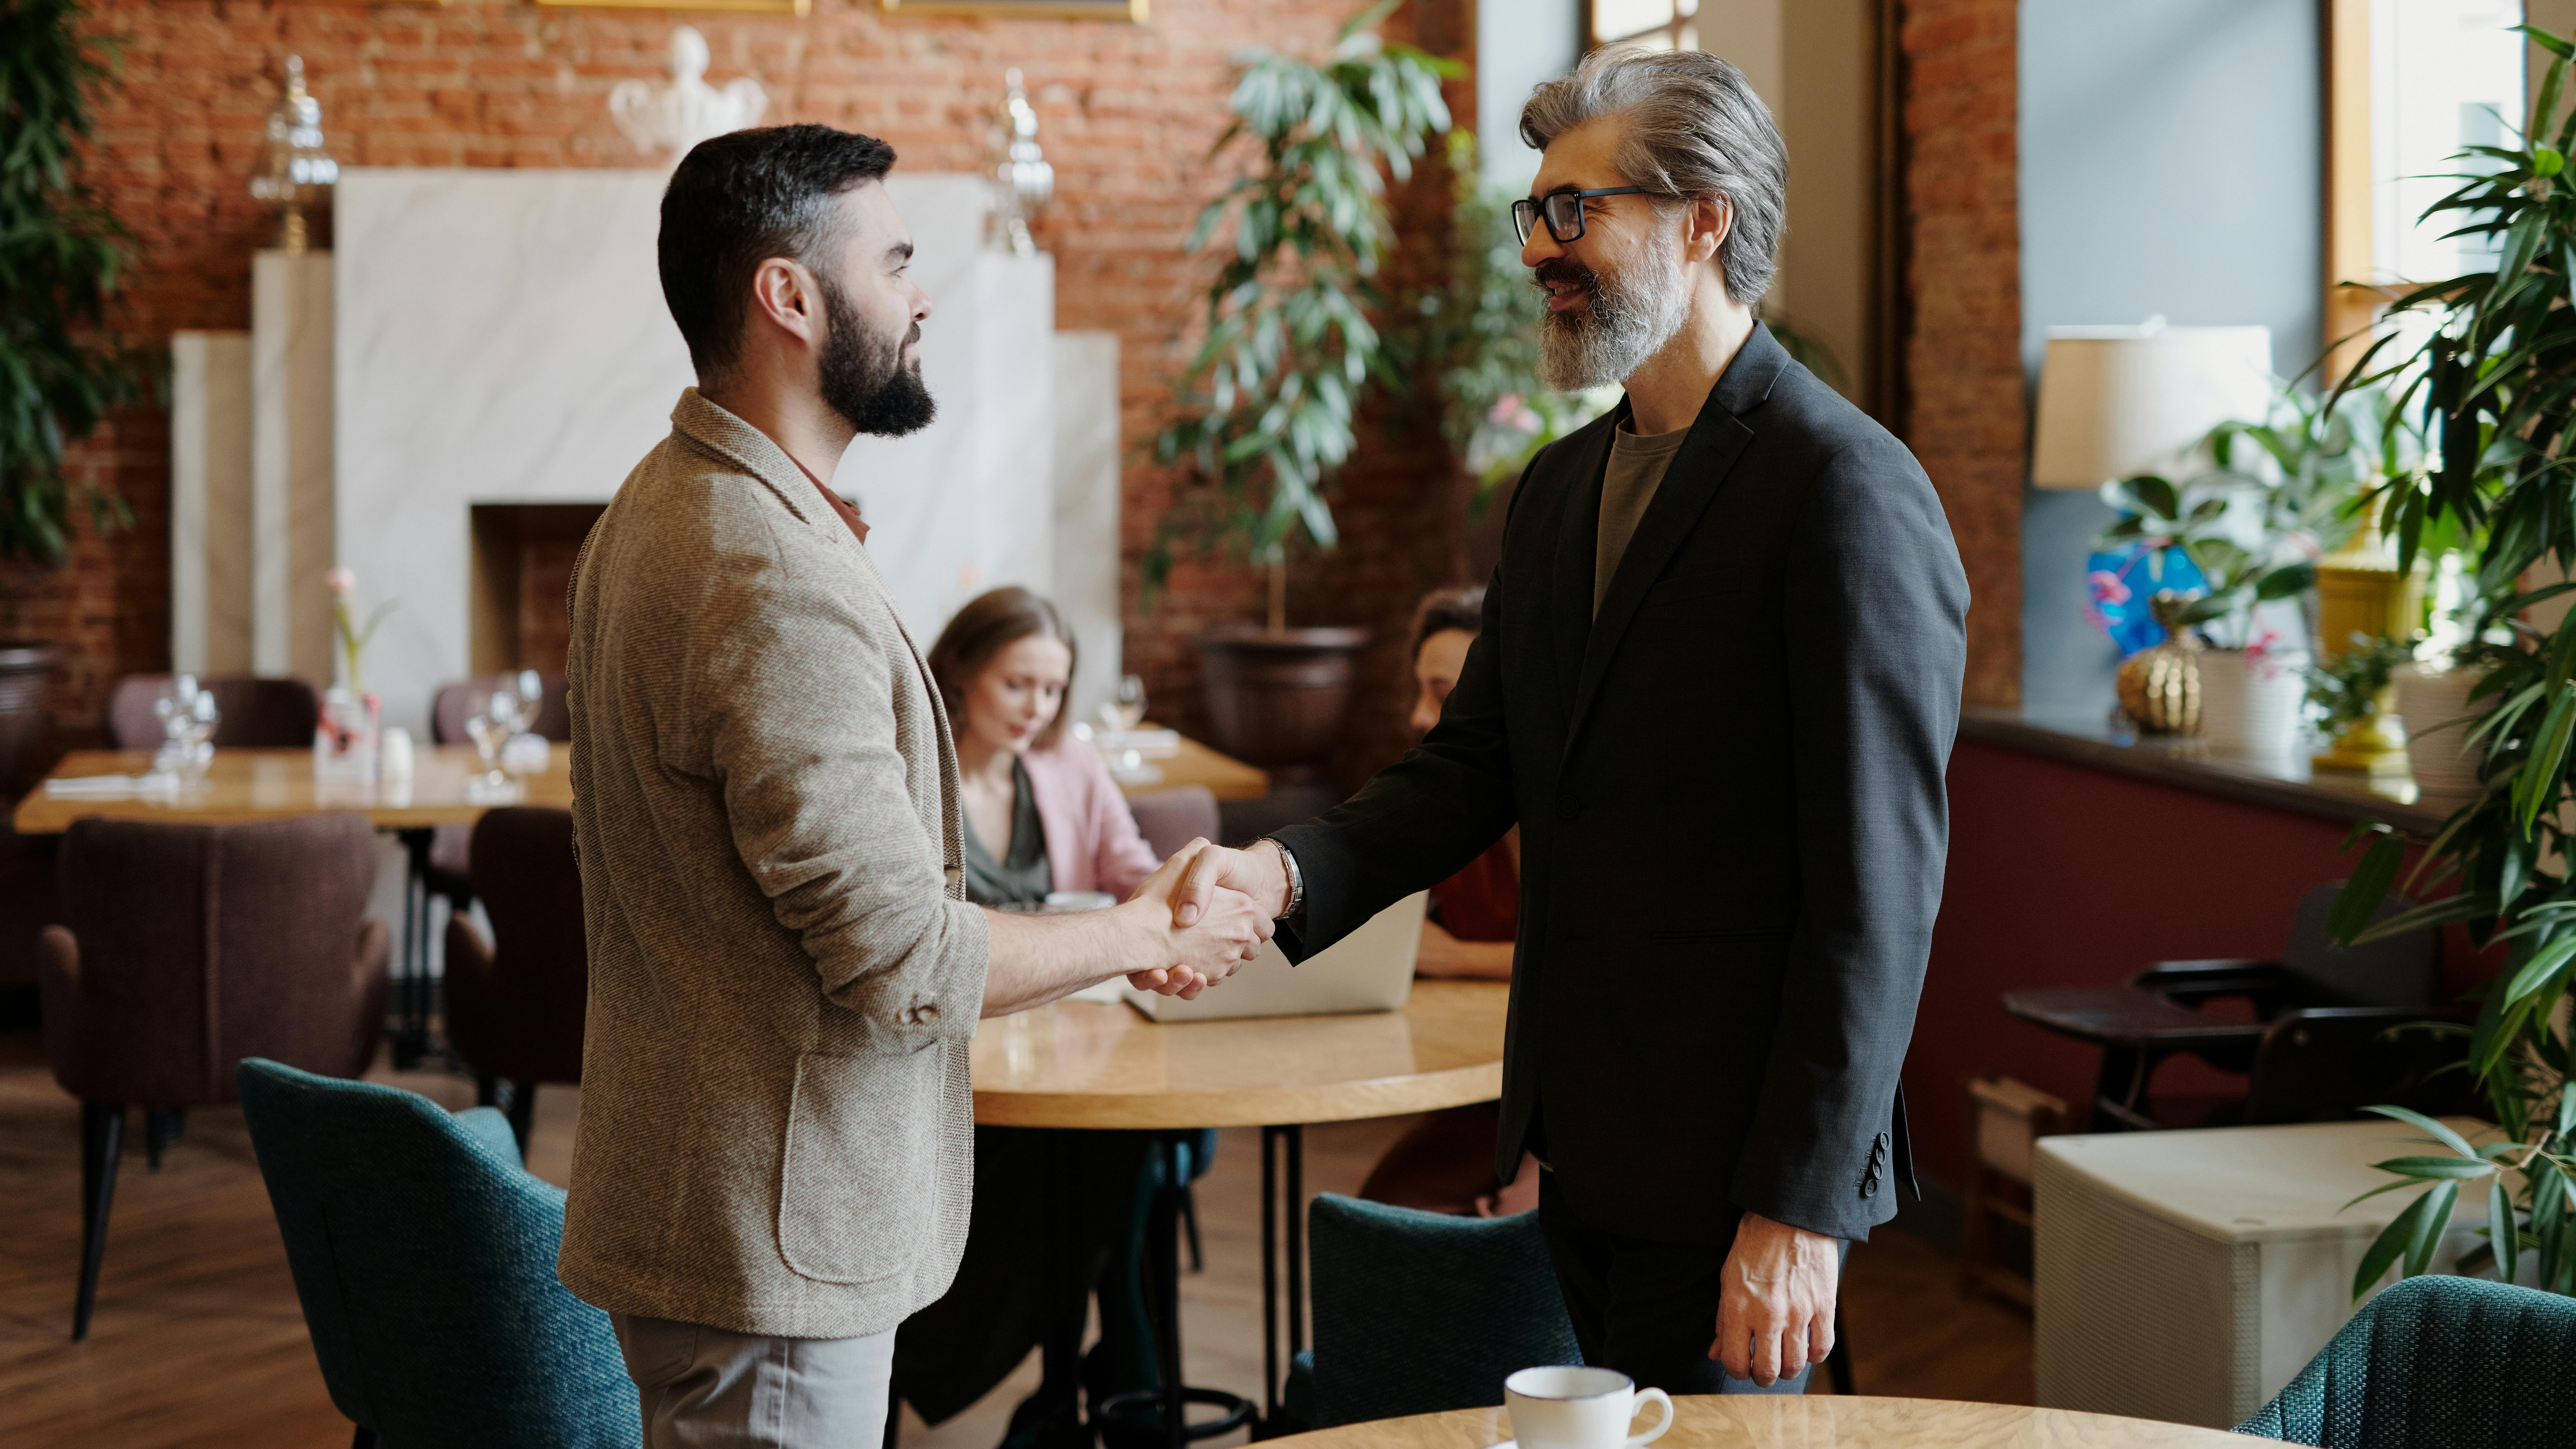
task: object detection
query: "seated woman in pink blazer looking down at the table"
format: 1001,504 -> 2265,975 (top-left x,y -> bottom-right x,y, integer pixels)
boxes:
894,588 -> 1169,1449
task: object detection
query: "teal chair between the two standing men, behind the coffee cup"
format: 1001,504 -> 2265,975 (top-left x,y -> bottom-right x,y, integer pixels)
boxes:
1288,1194 -> 1584,1428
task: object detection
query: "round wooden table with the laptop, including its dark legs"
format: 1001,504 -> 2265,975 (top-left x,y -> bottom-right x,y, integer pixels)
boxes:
974,982 -> 1509,1449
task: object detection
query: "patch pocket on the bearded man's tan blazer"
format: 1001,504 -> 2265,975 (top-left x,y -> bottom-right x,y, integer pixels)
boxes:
778,1052 -> 948,1284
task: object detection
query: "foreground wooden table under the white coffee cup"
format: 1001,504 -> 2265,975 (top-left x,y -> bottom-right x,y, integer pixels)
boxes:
1278,1385 -> 2259,1449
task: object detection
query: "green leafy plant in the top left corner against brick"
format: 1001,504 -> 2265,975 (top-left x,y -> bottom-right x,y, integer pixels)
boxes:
0,0 -> 142,565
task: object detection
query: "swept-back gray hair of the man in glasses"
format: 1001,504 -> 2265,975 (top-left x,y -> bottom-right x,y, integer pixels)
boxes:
1520,46 -> 1788,307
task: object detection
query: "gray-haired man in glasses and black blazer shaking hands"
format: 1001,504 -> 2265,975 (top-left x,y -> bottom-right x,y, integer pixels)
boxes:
1180,49 -> 1968,1392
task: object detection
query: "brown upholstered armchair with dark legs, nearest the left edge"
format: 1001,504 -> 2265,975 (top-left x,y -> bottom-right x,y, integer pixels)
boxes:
39,815 -> 389,1338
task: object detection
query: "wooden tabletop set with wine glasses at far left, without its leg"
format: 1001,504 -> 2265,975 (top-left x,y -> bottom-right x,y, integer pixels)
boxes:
15,745 -> 572,835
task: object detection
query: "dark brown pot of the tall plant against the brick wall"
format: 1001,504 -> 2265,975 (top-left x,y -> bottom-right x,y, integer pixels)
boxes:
1198,624 -> 1368,773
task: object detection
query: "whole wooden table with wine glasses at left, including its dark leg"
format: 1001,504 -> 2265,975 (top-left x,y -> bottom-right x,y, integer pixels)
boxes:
15,745 -> 572,1067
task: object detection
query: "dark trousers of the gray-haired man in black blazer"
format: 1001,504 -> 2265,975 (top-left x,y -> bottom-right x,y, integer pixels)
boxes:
1538,1173 -> 1814,1395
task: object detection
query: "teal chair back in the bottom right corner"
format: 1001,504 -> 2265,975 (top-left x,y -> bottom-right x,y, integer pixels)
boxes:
2236,1279 -> 2576,1449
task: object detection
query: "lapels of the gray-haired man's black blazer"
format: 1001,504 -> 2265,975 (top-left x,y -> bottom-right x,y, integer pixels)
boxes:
1558,322 -> 1788,755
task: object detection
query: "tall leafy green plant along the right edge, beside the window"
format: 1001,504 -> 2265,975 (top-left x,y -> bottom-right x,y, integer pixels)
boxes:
2329,20 -> 2576,1294
